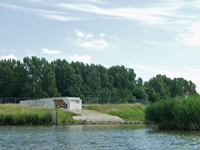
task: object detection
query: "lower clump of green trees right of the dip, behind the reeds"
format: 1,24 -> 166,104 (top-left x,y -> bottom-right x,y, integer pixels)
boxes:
144,75 -> 197,102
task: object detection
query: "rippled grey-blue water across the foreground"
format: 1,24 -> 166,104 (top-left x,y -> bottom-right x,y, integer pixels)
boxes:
0,125 -> 200,150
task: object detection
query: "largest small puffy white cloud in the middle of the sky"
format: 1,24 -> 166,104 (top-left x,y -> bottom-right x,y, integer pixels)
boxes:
76,39 -> 109,49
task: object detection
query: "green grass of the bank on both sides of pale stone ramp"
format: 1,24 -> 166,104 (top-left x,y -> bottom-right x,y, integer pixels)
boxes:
0,104 -> 145,125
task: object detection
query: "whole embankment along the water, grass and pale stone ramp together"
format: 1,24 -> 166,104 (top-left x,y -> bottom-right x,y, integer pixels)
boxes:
0,104 -> 144,125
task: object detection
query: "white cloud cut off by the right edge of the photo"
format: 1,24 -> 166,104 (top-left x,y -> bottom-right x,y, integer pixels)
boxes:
178,24 -> 200,46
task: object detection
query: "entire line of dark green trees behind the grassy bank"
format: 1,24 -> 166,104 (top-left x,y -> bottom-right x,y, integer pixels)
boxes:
0,56 -> 197,102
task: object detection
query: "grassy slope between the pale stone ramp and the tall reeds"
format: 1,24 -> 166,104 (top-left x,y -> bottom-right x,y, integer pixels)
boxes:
83,104 -> 145,121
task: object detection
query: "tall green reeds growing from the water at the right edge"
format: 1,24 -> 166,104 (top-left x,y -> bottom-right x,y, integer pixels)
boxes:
145,96 -> 200,130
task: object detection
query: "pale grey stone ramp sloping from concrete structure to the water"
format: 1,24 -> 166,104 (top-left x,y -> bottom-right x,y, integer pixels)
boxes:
71,110 -> 124,123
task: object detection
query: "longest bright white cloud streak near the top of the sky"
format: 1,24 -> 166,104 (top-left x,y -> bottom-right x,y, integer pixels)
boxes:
56,3 -> 177,24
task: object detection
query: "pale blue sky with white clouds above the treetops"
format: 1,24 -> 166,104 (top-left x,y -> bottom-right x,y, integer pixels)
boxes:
0,0 -> 200,93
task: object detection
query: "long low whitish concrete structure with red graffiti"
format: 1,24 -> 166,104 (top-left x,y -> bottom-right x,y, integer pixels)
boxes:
20,97 -> 82,110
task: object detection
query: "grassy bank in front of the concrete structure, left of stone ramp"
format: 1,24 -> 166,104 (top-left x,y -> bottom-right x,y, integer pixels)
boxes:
0,104 -> 79,125
